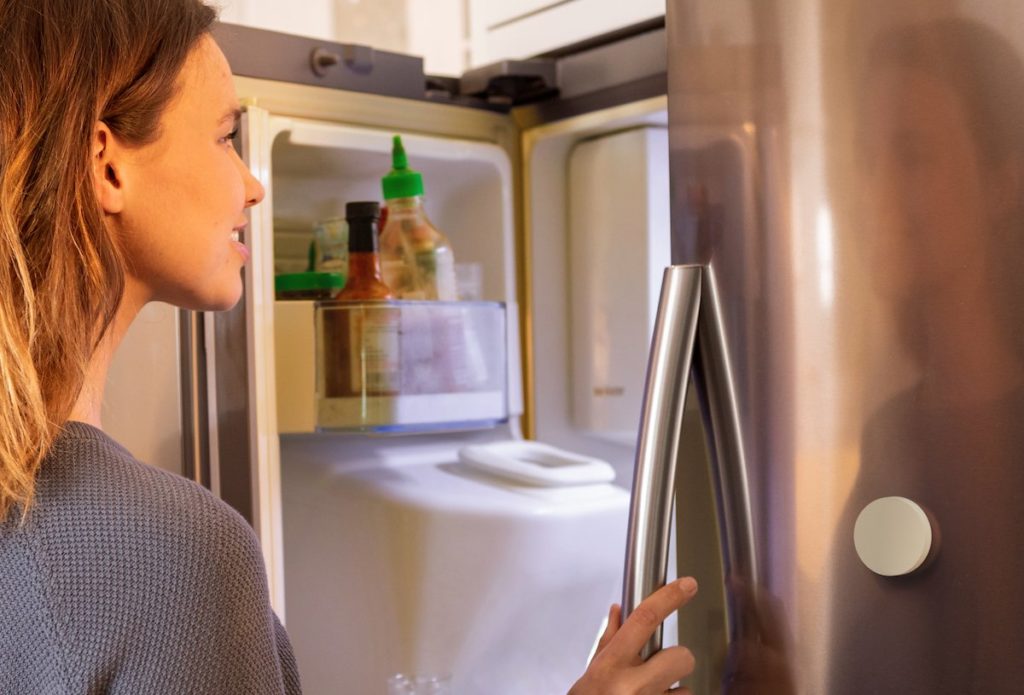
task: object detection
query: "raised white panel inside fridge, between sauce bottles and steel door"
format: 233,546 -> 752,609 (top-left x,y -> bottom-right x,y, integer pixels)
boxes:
569,127 -> 672,446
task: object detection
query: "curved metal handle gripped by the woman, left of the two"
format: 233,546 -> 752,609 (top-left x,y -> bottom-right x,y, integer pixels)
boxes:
623,265 -> 702,659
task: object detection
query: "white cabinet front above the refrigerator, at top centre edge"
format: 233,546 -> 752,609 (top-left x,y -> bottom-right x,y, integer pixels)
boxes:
469,0 -> 665,67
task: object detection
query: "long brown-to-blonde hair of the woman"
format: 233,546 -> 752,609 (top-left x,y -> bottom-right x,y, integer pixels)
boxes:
0,0 -> 216,520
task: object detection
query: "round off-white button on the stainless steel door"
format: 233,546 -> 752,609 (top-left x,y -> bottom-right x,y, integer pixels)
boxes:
853,497 -> 932,576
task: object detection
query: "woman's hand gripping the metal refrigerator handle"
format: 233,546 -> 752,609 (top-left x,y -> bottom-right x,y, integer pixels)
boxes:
569,577 -> 697,695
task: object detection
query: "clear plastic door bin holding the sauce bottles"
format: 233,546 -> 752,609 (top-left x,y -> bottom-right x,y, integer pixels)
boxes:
315,301 -> 508,432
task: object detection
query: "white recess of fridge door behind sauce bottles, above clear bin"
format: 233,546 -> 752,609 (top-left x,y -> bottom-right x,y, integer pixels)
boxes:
271,119 -> 515,302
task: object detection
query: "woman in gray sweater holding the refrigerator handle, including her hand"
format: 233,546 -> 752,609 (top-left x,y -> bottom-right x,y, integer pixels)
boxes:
0,0 -> 695,695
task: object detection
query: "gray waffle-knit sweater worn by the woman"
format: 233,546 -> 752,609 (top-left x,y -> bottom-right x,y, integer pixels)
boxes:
0,423 -> 300,695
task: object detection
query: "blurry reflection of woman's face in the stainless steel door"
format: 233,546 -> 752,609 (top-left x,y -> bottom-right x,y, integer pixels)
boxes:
863,68 -> 995,301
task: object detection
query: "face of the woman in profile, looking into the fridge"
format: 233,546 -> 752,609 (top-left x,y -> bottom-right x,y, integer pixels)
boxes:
116,37 -> 264,310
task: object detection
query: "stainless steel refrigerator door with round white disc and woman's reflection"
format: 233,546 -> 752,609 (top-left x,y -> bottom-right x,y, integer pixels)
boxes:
667,0 -> 1024,695
